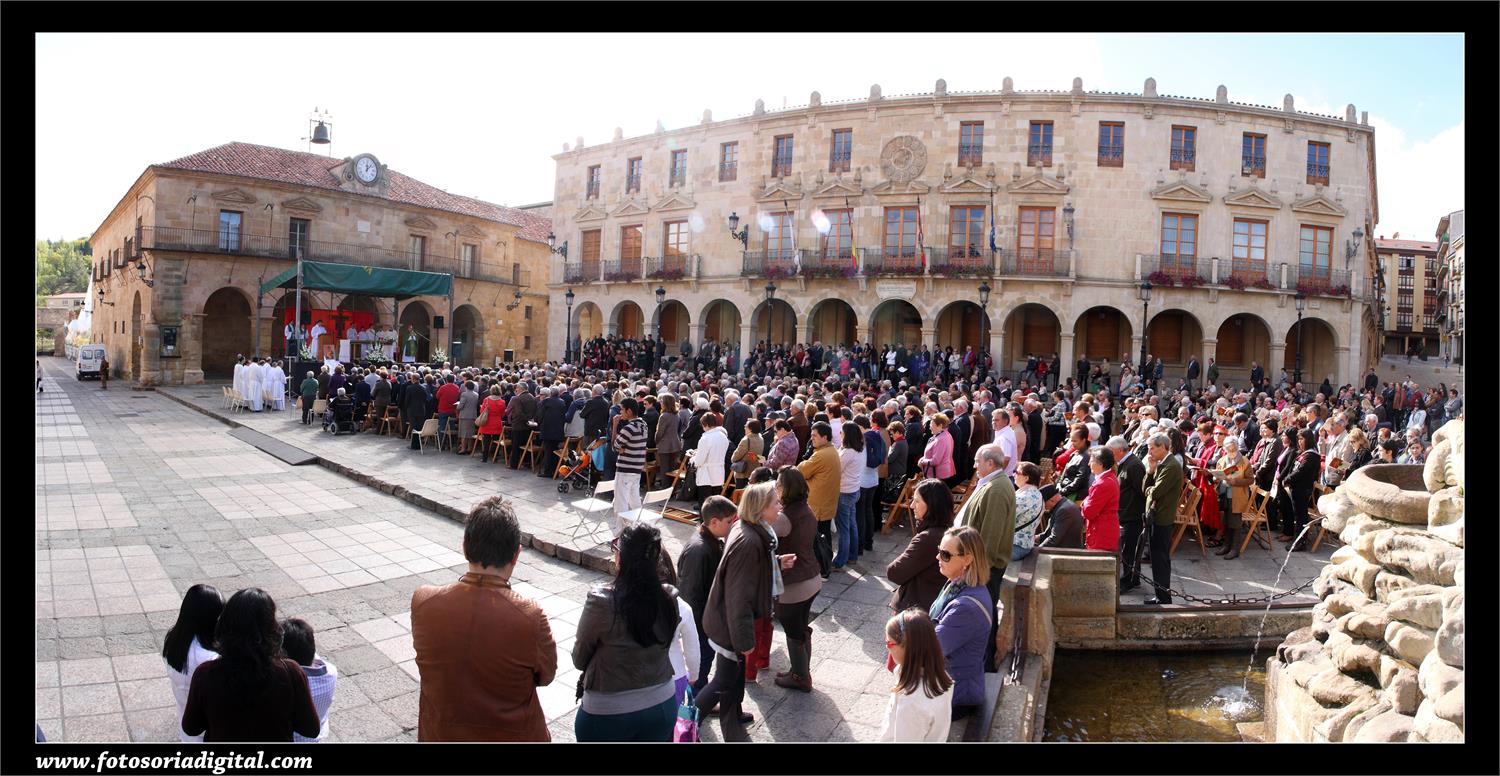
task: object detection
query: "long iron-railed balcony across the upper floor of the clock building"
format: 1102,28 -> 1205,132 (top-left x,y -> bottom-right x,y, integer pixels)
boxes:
138,227 -> 531,285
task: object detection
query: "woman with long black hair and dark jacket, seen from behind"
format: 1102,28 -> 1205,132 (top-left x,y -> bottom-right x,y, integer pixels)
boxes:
573,522 -> 680,741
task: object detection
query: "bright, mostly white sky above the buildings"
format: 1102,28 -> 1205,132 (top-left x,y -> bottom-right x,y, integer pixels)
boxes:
36,33 -> 1464,240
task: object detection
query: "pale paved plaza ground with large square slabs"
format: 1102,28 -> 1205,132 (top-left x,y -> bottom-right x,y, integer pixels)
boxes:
35,359 -> 1329,741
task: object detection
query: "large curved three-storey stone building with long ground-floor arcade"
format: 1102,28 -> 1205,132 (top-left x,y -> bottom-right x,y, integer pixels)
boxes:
548,80 -> 1379,384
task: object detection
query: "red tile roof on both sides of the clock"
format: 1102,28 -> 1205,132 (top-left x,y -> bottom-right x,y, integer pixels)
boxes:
155,143 -> 552,243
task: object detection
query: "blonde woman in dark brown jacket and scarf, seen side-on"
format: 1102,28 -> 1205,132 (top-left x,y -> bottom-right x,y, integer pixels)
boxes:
698,482 -> 795,741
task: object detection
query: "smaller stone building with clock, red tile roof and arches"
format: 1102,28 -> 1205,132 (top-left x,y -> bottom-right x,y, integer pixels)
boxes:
92,143 -> 551,384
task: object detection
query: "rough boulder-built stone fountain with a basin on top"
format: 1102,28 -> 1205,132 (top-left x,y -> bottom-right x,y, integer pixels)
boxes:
1265,420 -> 1464,743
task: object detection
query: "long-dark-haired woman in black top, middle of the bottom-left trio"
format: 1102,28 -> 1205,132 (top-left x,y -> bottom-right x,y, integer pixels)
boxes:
182,587 -> 323,741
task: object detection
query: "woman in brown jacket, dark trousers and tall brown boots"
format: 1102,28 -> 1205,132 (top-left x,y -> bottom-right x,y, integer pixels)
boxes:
776,467 -> 824,692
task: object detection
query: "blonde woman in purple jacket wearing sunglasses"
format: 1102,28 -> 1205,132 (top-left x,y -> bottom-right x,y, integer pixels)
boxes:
929,525 -> 995,719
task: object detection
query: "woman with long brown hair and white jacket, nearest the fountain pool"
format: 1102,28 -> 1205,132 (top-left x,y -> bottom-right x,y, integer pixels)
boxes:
878,606 -> 954,741
